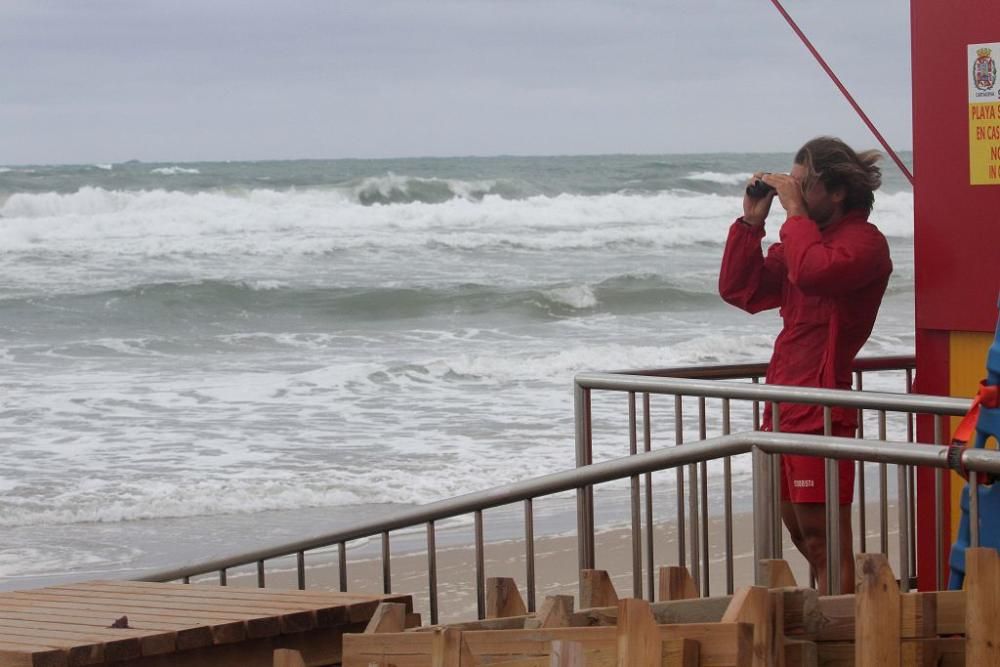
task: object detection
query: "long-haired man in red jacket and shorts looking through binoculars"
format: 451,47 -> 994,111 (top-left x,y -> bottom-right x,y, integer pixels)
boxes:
719,137 -> 892,593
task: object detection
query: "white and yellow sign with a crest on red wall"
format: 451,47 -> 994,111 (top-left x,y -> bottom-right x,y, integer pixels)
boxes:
967,42 -> 1000,185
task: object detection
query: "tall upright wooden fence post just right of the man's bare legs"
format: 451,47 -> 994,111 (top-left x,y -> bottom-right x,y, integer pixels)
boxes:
854,554 -> 904,667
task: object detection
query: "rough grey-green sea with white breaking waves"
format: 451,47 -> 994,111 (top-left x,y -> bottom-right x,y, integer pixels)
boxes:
0,153 -> 913,589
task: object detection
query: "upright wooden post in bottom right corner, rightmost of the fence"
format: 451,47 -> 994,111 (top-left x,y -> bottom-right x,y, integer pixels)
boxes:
965,547 -> 1000,665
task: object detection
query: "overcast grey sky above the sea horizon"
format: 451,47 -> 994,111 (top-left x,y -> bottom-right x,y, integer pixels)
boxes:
0,0 -> 912,165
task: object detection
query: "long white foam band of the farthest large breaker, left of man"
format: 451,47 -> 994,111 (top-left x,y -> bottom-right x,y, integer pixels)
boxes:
0,188 -> 760,264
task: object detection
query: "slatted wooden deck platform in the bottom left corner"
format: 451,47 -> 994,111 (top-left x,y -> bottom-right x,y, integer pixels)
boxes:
0,581 -> 412,667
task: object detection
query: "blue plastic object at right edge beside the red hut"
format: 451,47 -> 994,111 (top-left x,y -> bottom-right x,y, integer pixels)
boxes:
948,298 -> 1000,590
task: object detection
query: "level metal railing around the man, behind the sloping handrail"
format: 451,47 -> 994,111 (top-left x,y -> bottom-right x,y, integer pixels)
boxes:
575,357 -> 969,596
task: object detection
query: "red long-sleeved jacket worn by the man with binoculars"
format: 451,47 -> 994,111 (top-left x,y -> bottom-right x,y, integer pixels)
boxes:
719,211 -> 892,433
